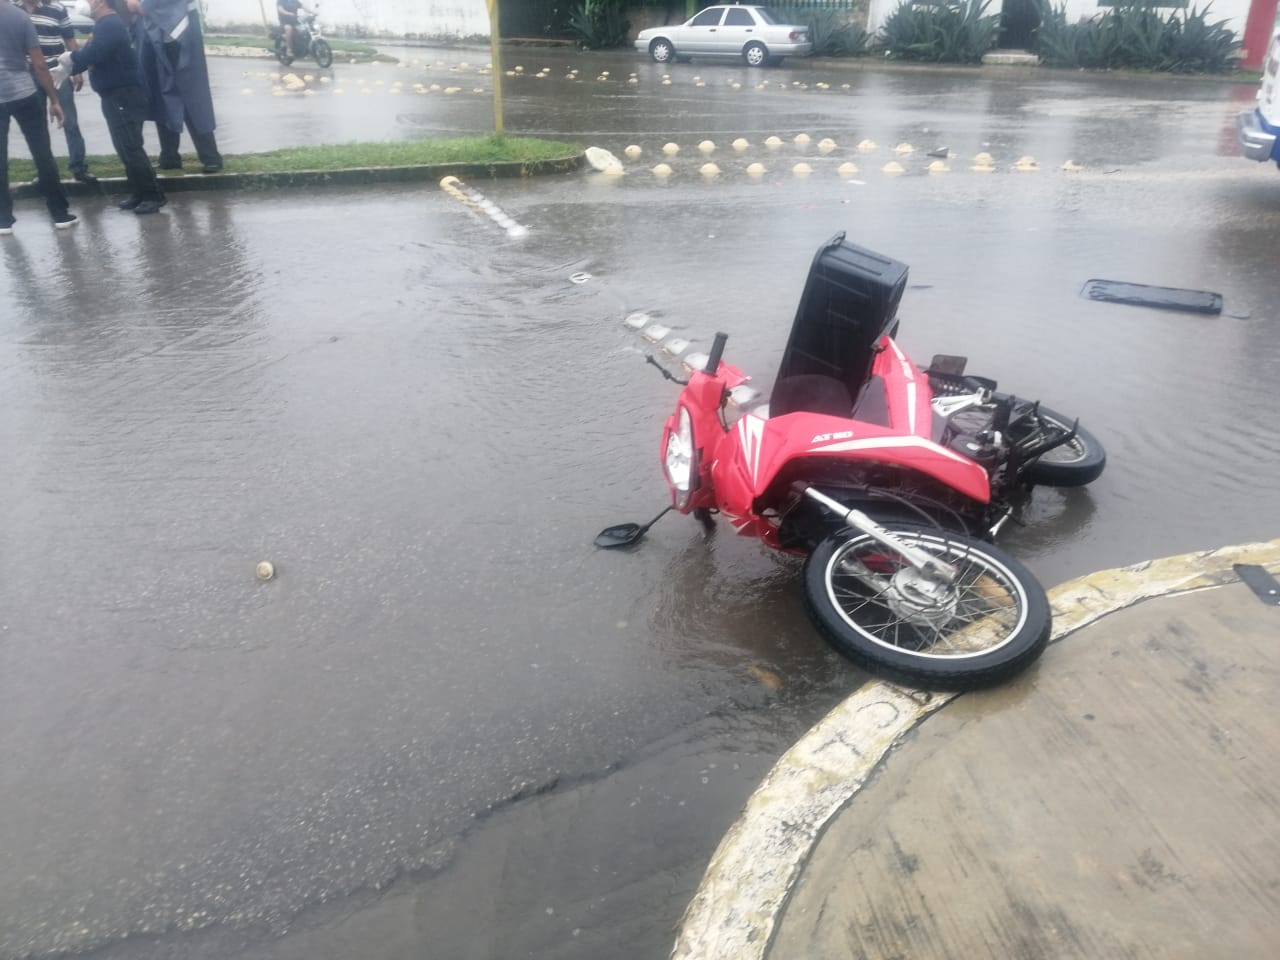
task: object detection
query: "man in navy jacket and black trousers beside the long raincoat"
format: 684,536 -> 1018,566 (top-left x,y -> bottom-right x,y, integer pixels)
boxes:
66,0 -> 165,214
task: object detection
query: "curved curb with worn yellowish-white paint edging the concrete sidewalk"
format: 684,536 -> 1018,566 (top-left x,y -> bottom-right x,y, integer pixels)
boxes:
671,540 -> 1280,960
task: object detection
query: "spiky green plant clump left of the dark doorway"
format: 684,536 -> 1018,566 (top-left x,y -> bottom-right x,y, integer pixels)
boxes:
879,0 -> 1000,63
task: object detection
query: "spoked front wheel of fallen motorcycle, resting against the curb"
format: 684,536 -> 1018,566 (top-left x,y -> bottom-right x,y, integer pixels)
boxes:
804,521 -> 1052,690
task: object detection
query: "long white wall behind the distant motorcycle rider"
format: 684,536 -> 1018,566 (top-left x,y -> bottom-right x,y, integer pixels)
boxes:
204,0 -> 486,37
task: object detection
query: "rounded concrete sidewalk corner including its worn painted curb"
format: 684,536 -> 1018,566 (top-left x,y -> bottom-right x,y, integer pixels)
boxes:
673,540 -> 1280,960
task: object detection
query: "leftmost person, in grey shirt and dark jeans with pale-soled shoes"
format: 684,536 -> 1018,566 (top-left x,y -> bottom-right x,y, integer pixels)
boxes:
0,3 -> 76,234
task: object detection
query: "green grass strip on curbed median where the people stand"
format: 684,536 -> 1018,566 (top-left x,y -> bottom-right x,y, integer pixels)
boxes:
9,134 -> 582,184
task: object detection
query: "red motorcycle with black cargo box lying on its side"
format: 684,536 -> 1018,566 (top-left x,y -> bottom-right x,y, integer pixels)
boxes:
595,233 -> 1106,689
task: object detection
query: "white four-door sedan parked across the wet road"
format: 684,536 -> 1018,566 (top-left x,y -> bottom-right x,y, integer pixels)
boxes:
636,4 -> 813,67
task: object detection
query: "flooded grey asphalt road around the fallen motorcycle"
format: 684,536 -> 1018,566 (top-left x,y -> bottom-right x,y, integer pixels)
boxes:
0,51 -> 1280,959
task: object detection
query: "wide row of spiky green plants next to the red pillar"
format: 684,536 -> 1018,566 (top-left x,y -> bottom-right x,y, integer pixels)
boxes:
1037,0 -> 1240,73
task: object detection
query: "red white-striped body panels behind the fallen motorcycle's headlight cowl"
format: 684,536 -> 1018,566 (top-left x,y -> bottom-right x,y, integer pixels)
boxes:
712,337 -> 991,539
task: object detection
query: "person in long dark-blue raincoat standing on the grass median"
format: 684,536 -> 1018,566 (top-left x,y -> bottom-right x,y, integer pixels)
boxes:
127,0 -> 223,173
